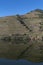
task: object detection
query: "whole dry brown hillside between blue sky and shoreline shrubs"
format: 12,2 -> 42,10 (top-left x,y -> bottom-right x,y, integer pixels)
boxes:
0,9 -> 43,36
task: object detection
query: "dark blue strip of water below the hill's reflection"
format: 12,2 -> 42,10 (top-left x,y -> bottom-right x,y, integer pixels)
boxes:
0,59 -> 43,65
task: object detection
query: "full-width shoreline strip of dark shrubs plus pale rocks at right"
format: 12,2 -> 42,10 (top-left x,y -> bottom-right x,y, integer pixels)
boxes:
1,34 -> 43,44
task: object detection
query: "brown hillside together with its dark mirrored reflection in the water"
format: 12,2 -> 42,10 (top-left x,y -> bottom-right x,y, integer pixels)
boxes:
0,9 -> 43,62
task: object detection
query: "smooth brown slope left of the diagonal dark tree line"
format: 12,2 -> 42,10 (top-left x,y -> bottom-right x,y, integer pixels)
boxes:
0,16 -> 28,35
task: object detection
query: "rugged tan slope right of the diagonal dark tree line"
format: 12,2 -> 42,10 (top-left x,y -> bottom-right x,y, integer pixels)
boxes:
22,9 -> 43,36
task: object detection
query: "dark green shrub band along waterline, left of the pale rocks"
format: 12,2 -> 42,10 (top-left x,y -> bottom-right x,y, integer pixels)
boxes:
1,34 -> 31,44
